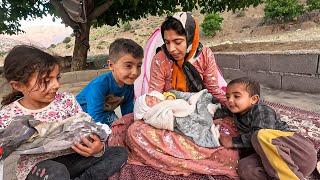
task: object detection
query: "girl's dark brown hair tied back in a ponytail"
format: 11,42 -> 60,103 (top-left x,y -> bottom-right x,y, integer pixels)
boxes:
1,45 -> 59,106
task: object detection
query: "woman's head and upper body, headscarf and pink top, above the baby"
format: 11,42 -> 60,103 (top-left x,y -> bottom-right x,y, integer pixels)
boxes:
149,12 -> 226,103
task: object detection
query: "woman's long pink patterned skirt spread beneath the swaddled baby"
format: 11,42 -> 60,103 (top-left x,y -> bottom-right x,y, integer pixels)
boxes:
108,115 -> 239,179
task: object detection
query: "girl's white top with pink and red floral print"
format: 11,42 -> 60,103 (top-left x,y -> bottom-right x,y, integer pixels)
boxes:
0,92 -> 83,179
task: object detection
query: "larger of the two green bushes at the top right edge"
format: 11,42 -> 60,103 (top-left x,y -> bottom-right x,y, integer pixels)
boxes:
264,0 -> 304,21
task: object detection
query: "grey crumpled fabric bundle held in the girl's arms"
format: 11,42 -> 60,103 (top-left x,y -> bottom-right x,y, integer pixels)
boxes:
0,113 -> 111,159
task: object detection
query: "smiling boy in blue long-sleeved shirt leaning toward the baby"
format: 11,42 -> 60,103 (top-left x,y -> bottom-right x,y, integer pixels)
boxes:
76,38 -> 143,125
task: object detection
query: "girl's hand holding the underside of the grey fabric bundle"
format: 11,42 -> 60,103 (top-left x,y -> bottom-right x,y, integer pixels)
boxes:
71,134 -> 104,157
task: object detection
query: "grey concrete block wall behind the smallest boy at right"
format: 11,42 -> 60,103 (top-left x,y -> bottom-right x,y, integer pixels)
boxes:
215,52 -> 320,93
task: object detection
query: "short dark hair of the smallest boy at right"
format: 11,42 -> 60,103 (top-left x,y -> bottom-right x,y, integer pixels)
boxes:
228,77 -> 260,96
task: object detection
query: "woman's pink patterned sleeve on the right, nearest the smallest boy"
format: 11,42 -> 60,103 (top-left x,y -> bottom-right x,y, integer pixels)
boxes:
203,48 -> 227,104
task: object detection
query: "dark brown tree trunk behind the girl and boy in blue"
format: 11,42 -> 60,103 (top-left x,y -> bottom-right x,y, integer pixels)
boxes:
71,22 -> 90,71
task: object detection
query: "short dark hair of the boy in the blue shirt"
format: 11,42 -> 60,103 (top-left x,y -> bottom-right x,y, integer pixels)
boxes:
109,38 -> 143,62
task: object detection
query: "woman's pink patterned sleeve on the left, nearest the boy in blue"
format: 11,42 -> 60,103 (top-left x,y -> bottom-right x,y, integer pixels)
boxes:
149,55 -> 169,93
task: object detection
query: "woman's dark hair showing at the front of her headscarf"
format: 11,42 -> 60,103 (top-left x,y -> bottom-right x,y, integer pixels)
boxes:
161,16 -> 187,39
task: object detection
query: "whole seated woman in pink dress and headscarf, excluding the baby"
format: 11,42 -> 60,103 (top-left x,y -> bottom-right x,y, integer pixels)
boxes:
109,13 -> 238,178
